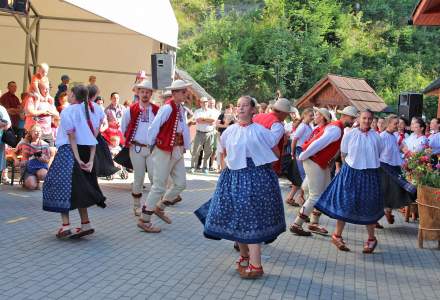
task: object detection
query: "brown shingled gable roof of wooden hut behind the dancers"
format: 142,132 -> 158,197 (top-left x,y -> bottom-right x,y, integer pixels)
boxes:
295,74 -> 387,112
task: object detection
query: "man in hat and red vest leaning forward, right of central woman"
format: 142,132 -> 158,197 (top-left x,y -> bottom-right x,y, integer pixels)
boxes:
290,106 -> 358,236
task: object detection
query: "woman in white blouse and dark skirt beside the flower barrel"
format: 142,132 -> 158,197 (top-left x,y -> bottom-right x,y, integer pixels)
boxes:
380,115 -> 416,224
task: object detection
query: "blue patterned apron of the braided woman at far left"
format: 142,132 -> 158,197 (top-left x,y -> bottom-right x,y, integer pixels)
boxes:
43,144 -> 75,213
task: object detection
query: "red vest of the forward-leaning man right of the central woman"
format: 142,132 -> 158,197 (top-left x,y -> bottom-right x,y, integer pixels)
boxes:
302,120 -> 344,169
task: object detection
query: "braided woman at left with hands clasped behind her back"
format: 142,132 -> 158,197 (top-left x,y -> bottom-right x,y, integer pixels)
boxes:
43,85 -> 106,238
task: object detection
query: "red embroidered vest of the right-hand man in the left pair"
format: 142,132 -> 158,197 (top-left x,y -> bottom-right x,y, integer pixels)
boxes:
156,98 -> 180,152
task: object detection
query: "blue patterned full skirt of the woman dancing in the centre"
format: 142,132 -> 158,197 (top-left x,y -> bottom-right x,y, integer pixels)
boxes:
202,158 -> 286,244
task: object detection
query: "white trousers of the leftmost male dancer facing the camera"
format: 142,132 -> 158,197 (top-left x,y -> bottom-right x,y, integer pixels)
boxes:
129,145 -> 154,195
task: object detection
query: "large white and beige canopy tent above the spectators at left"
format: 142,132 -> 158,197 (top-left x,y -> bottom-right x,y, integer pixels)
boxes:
0,0 -> 178,100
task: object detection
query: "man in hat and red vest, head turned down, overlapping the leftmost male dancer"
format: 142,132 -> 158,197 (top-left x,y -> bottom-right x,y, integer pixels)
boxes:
138,80 -> 191,233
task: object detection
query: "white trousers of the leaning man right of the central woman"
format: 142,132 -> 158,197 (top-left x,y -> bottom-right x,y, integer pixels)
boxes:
300,159 -> 331,216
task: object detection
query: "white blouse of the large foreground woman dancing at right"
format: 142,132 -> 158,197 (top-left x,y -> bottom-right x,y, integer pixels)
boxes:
341,128 -> 382,170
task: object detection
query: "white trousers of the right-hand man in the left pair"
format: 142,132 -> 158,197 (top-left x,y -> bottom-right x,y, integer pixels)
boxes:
146,147 -> 186,210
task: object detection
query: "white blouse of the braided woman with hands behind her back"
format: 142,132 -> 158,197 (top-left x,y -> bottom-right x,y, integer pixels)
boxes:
55,104 -> 99,148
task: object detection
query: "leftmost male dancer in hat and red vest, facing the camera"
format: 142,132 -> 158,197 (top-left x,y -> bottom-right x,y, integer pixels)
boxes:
121,80 -> 159,216
